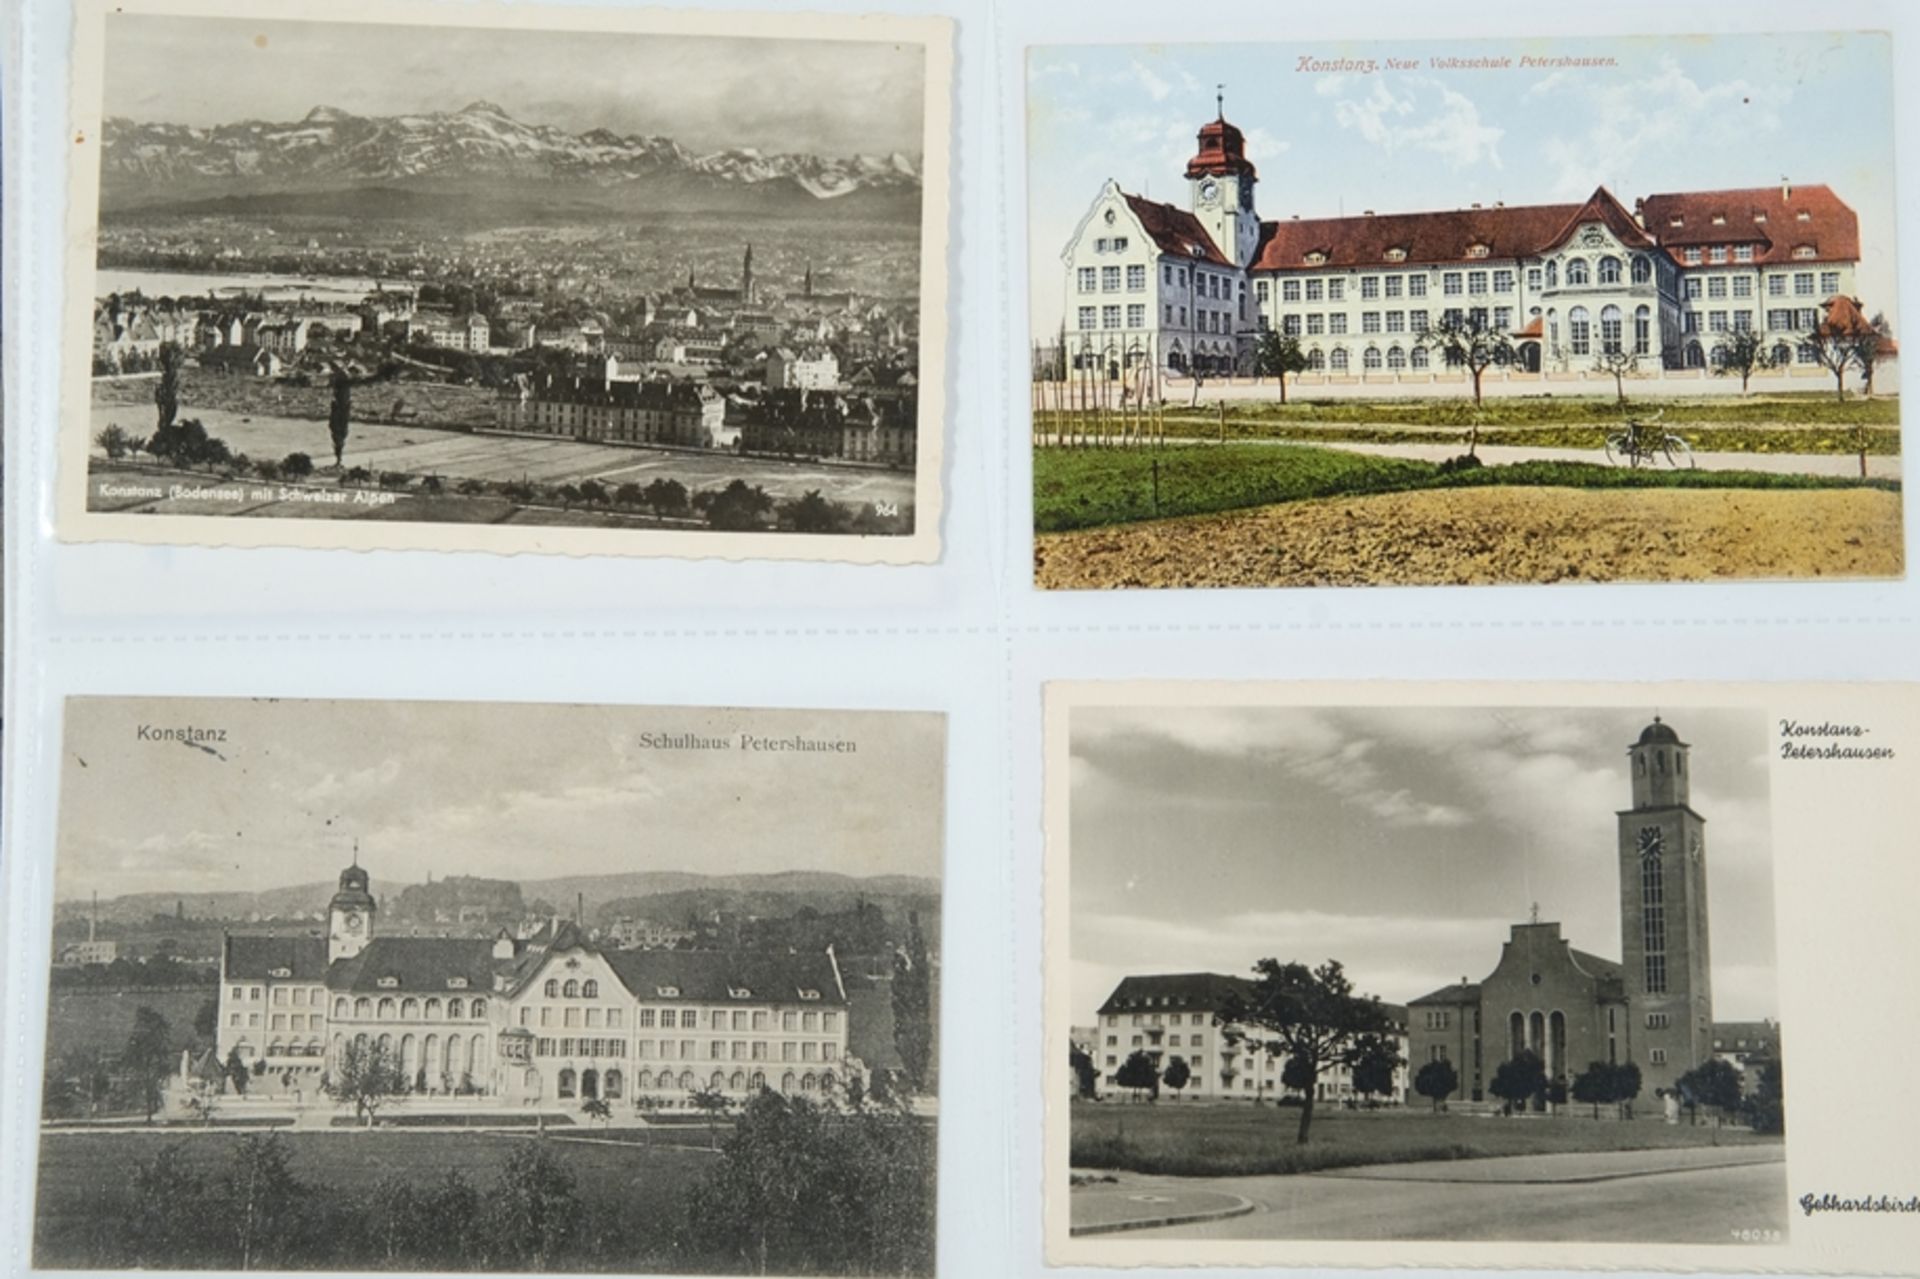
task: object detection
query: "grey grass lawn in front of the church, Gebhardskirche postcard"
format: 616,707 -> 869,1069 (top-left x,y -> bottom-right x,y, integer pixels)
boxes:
1069,1102 -> 1780,1177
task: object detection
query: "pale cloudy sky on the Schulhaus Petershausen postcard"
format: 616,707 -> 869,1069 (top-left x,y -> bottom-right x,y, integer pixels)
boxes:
56,697 -> 945,901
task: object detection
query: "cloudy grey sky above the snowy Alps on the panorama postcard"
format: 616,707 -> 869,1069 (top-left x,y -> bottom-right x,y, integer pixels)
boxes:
104,15 -> 925,156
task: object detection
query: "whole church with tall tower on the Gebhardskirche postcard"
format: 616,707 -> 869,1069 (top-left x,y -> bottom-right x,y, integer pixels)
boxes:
1407,716 -> 1715,1102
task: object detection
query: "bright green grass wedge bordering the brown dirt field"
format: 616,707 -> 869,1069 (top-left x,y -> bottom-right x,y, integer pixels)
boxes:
1033,444 -> 1899,534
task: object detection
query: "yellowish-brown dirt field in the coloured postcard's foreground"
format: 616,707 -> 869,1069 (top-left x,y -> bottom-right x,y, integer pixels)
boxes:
1033,488 -> 1903,590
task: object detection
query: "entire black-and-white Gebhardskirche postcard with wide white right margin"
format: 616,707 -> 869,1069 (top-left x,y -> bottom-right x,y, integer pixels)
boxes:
1044,682 -> 1920,1273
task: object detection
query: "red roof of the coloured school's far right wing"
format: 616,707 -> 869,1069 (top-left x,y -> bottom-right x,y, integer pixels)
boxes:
1642,184 -> 1860,265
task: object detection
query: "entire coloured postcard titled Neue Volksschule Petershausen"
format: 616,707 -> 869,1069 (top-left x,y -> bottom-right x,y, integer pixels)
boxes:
1027,33 -> 1905,590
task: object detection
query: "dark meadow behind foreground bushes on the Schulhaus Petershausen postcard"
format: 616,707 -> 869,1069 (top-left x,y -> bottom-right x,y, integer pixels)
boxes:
35,1131 -> 714,1271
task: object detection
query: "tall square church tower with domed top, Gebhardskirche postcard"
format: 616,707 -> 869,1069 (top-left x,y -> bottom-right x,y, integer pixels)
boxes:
1619,716 -> 1713,1097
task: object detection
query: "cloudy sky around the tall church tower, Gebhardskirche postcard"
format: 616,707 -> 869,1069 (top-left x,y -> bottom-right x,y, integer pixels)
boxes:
1069,707 -> 1778,1024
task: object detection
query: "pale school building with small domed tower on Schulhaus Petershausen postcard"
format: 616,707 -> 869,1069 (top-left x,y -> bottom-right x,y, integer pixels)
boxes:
217,860 -> 864,1104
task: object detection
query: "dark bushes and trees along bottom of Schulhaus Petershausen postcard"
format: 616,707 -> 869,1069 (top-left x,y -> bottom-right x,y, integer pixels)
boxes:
71,1091 -> 935,1275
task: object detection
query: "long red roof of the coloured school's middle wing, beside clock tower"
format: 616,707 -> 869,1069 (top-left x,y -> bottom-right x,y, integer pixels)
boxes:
1254,186 -> 1653,271
